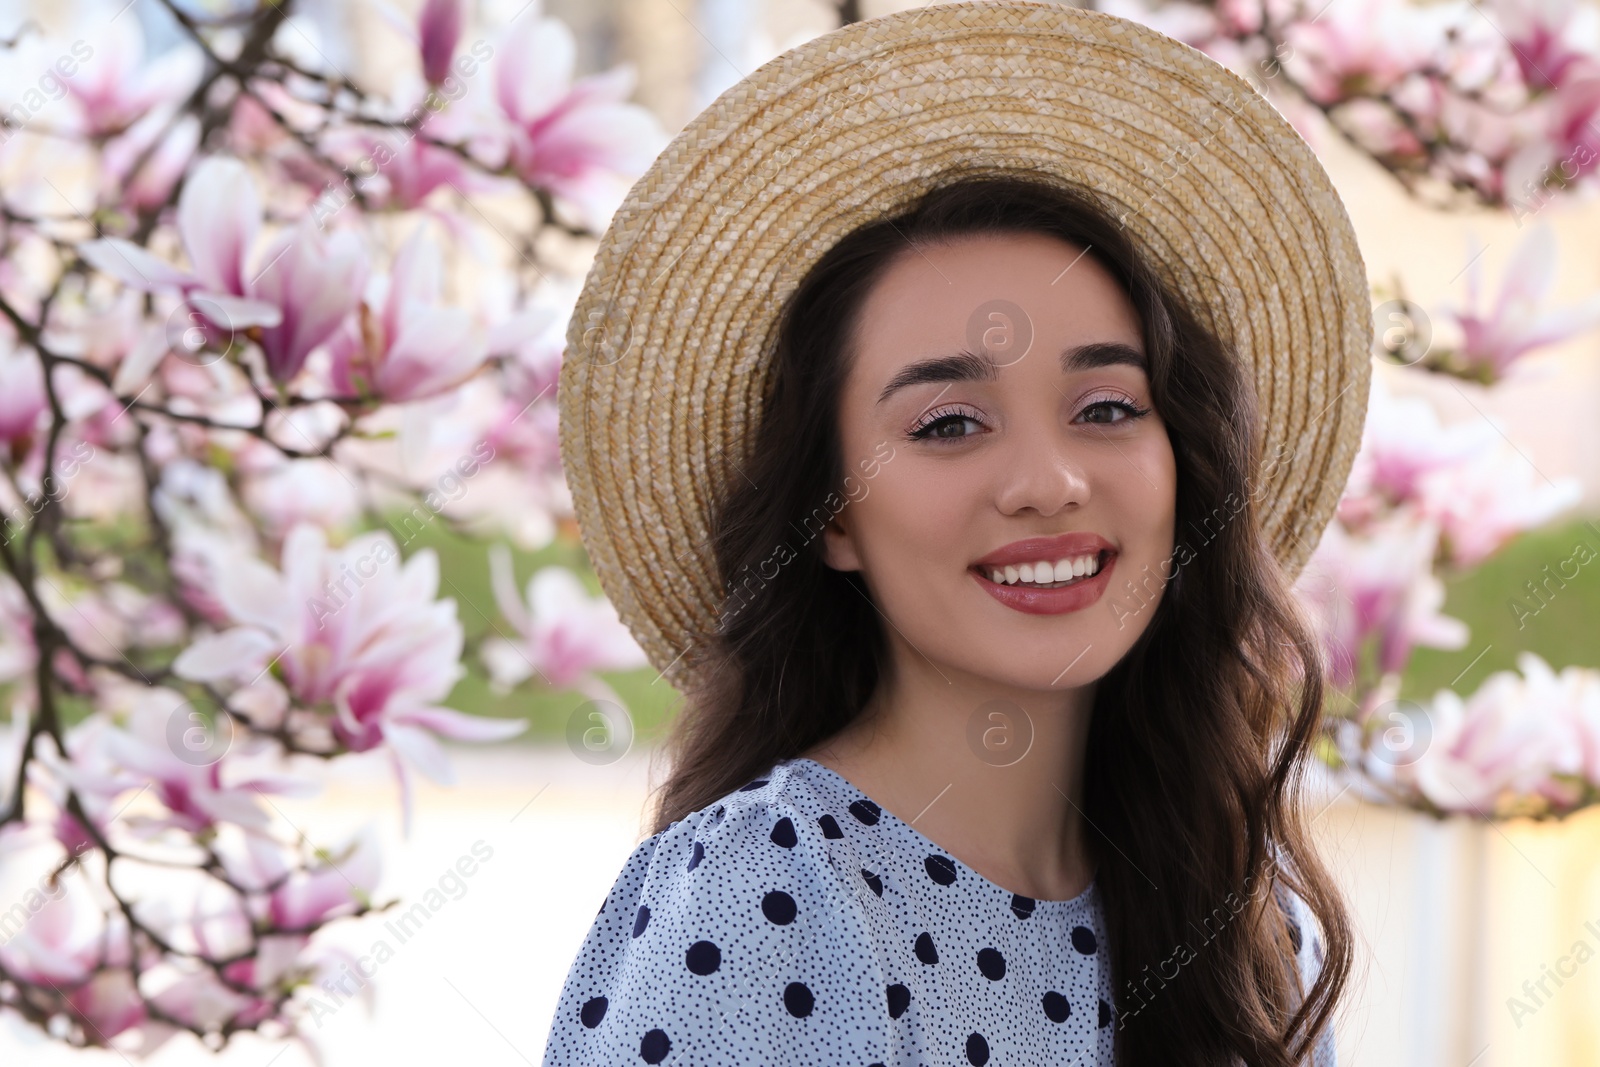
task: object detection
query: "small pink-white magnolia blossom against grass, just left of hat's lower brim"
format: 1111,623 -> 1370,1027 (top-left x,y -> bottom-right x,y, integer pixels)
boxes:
483,545 -> 648,699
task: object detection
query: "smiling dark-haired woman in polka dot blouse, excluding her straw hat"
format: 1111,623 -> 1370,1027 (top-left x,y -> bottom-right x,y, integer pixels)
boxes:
546,5 -> 1365,1065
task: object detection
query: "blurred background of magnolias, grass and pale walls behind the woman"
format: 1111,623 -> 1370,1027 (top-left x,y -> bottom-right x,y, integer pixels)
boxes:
0,0 -> 1600,1067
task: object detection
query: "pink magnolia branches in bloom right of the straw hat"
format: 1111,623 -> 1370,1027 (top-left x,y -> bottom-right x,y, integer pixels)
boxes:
1098,0 -> 1600,819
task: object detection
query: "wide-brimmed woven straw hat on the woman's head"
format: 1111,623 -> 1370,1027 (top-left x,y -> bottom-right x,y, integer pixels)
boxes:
558,0 -> 1373,688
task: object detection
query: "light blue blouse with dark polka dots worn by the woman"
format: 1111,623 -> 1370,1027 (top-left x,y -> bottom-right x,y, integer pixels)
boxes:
542,758 -> 1334,1067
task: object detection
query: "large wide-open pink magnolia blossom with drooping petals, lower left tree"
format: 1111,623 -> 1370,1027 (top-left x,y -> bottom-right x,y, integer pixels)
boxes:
173,523 -> 528,832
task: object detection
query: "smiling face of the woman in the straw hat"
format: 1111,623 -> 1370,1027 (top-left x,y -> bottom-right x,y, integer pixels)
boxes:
826,234 -> 1176,689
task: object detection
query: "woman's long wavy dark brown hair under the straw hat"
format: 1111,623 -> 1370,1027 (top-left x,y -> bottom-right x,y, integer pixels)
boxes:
636,176 -> 1352,1067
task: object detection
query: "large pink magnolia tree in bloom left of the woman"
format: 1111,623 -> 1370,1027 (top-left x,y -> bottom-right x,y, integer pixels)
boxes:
0,0 -> 652,1054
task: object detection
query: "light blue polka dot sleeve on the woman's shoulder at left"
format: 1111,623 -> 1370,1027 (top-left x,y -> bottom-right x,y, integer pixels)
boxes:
544,764 -> 888,1065
